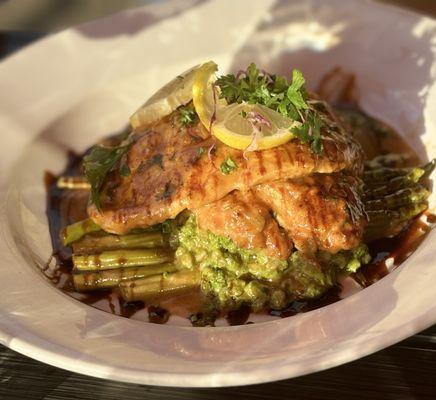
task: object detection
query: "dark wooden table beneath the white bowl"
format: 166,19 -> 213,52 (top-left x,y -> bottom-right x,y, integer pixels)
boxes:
0,0 -> 436,400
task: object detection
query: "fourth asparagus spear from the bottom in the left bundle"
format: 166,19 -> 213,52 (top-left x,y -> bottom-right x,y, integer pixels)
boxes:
73,232 -> 165,254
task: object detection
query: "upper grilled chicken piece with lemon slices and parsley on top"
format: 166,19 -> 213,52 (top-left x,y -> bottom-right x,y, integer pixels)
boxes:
88,103 -> 362,247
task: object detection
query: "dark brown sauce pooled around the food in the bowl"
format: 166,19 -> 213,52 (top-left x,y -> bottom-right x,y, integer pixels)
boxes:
43,102 -> 436,326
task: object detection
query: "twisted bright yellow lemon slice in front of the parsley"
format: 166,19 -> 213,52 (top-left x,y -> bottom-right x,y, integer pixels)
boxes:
192,61 -> 301,151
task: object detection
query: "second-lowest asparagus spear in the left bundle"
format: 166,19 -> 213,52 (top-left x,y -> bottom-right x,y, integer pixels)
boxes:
73,264 -> 177,292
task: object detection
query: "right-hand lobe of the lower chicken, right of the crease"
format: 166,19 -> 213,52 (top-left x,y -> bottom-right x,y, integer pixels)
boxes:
253,174 -> 366,253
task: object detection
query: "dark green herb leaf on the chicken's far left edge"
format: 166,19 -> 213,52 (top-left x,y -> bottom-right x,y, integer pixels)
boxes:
83,143 -> 131,210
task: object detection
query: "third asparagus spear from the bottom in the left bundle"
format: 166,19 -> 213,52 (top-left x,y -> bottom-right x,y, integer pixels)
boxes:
73,249 -> 173,271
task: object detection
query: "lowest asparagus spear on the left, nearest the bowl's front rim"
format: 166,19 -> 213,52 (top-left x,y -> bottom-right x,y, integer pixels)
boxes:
120,269 -> 200,301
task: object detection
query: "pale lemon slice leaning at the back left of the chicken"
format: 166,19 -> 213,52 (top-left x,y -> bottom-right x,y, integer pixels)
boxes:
130,65 -> 200,130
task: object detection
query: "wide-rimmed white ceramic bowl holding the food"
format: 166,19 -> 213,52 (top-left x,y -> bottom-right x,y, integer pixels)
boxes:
0,0 -> 436,386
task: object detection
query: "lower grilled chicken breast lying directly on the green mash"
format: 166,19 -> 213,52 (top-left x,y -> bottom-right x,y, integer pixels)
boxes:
194,174 -> 366,259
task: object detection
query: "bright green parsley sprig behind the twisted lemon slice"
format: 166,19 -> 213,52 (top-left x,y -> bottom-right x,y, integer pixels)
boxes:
216,63 -> 323,154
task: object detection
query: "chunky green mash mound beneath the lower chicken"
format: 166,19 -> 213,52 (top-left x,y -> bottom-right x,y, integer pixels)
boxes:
174,216 -> 370,311
